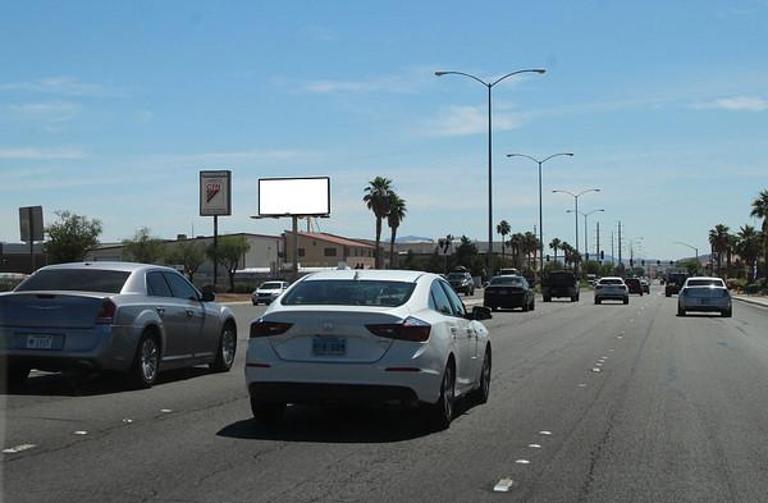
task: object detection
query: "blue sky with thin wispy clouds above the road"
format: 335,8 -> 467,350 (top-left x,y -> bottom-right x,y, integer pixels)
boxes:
0,0 -> 768,258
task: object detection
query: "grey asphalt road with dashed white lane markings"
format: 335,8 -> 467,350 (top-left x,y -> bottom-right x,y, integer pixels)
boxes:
2,287 -> 768,503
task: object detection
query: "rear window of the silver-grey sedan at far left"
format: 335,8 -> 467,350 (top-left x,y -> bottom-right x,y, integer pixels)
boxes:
16,269 -> 130,293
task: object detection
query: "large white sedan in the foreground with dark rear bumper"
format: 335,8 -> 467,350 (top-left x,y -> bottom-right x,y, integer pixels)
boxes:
245,270 -> 491,428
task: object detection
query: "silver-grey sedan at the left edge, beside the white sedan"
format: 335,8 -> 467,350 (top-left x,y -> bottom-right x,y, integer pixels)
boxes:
0,262 -> 237,387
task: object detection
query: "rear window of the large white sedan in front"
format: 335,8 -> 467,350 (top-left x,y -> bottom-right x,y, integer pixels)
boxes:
281,280 -> 416,307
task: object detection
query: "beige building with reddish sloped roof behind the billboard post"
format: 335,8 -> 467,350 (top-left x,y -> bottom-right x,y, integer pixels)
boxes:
283,231 -> 376,269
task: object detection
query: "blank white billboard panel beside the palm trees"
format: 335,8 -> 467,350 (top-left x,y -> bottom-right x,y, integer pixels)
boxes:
259,176 -> 331,216
